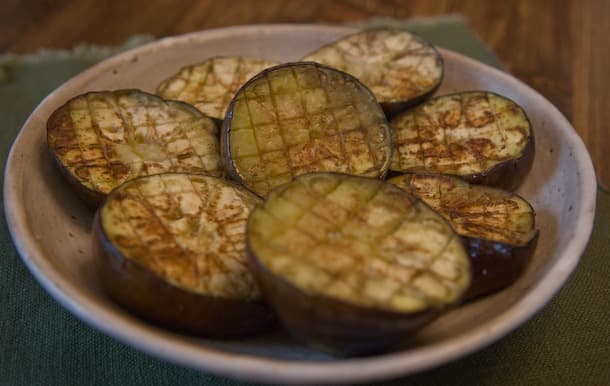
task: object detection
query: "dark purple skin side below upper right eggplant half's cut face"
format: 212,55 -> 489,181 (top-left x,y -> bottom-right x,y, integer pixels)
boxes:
456,131 -> 536,192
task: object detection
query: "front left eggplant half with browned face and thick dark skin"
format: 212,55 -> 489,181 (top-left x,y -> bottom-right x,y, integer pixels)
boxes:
93,173 -> 273,338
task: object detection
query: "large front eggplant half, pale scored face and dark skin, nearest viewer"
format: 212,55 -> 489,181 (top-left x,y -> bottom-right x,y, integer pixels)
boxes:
247,173 -> 470,355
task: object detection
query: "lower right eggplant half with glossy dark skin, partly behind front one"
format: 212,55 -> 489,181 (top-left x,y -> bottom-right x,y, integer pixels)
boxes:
388,174 -> 538,299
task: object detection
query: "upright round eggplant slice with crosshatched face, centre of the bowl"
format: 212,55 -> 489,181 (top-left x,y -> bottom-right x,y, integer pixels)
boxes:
221,63 -> 392,197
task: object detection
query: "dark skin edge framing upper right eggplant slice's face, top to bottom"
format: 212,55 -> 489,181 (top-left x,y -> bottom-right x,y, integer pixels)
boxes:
389,90 -> 536,192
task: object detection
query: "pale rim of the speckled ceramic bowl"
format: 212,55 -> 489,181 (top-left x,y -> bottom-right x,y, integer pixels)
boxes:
3,24 -> 597,384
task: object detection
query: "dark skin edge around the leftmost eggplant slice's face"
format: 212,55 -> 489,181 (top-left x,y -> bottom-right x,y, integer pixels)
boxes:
46,89 -> 224,210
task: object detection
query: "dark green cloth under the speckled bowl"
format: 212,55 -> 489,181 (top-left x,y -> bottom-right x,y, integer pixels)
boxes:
0,17 -> 610,385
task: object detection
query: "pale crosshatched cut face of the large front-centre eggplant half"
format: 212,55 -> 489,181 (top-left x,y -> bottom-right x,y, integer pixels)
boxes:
248,173 -> 470,312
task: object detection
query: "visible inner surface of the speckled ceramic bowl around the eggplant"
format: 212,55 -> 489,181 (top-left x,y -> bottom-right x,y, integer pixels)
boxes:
13,27 -> 581,360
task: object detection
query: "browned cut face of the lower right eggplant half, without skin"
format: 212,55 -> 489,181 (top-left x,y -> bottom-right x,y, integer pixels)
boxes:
390,174 -> 536,245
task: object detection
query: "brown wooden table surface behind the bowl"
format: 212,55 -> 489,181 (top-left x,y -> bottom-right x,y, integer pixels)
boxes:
0,0 -> 610,188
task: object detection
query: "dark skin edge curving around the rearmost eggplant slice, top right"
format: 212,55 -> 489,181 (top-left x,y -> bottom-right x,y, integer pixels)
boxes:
303,27 -> 445,120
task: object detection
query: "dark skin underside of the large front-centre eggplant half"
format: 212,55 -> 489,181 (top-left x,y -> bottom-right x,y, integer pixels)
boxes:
248,247 -> 444,357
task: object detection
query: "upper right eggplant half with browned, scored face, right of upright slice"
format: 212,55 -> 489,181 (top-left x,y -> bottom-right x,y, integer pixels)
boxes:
391,91 -> 534,190
